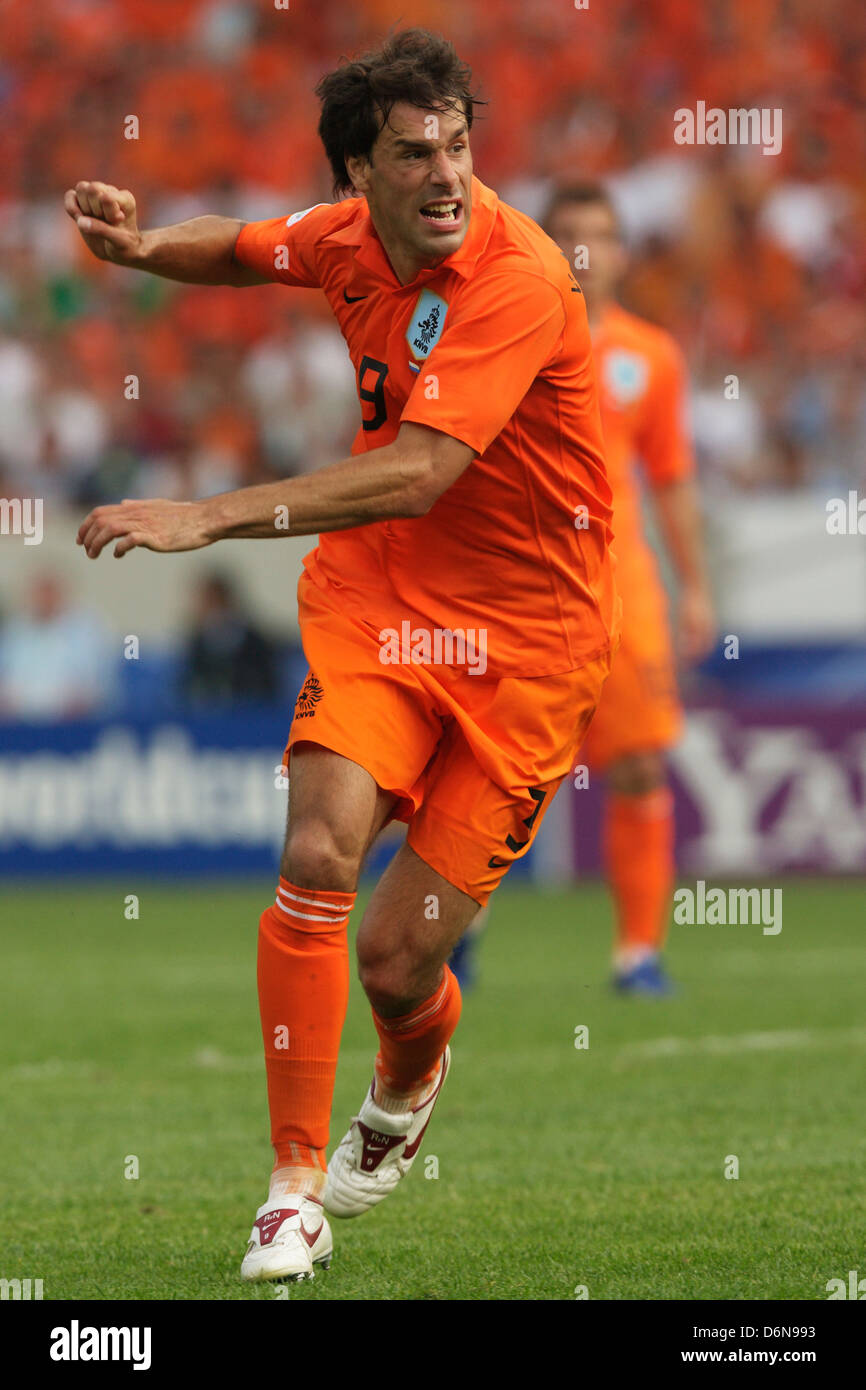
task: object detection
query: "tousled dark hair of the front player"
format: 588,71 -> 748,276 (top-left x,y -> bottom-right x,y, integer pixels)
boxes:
316,29 -> 487,197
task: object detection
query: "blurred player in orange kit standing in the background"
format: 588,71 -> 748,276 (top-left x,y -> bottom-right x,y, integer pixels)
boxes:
544,183 -> 714,994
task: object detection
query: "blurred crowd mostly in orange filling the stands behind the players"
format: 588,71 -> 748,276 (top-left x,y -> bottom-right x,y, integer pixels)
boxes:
0,0 -> 866,507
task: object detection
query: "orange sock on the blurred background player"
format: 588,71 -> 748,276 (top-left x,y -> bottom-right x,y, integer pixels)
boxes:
605,787 -> 674,965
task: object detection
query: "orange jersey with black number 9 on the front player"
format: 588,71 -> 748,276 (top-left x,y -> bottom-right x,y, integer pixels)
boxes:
235,178 -> 619,676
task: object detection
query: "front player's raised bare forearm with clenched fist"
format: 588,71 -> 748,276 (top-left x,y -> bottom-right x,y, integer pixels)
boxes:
64,179 -> 265,288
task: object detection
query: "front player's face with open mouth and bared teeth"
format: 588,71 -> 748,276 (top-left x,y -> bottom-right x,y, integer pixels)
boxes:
346,101 -> 473,282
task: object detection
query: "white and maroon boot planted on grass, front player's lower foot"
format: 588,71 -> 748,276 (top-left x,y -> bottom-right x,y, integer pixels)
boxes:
240,1193 -> 334,1280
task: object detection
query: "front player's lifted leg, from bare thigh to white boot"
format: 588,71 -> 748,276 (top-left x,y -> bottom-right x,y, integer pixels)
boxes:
325,845 -> 478,1216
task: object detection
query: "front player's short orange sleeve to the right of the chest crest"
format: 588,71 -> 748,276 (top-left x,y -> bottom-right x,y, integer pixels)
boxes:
400,272 -> 566,455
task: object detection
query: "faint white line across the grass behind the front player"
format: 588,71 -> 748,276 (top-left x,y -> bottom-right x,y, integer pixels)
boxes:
6,1027 -> 866,1081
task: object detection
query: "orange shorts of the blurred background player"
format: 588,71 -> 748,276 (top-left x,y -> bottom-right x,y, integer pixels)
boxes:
581,572 -> 683,771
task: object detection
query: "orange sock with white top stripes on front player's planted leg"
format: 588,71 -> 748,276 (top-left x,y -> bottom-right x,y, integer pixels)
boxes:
259,877 -> 356,1200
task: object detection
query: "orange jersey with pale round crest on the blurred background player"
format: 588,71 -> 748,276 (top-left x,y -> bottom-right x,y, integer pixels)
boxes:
592,304 -> 694,594
